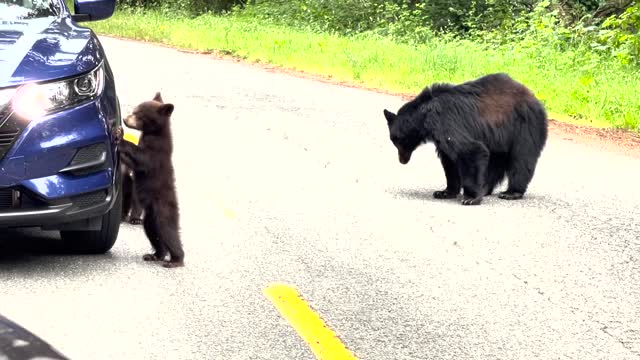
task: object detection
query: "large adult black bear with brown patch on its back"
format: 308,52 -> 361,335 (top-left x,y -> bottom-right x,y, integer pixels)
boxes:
383,73 -> 548,205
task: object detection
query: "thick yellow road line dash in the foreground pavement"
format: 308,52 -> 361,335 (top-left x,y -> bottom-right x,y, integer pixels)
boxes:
262,283 -> 356,360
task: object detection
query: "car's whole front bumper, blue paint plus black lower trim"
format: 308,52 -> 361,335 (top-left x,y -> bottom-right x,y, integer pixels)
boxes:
0,67 -> 121,230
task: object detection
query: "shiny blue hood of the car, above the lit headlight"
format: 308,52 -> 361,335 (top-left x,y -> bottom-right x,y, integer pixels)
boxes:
0,17 -> 103,88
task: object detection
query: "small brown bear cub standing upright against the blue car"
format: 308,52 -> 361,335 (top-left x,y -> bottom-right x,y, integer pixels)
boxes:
119,92 -> 184,268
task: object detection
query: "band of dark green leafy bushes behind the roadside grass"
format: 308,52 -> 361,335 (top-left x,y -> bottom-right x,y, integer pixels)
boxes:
119,0 -> 640,69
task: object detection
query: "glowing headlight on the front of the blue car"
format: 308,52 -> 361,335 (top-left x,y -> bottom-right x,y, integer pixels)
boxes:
11,66 -> 104,120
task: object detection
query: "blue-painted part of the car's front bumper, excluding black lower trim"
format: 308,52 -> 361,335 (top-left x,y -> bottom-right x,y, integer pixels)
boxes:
0,98 -> 119,195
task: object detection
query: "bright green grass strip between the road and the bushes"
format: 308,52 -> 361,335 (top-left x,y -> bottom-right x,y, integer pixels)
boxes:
87,8 -> 640,131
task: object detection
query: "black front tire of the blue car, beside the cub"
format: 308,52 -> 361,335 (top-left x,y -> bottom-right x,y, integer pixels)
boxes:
60,190 -> 122,254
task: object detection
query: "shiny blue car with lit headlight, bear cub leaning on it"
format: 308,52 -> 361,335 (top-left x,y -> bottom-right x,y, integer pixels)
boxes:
0,0 -> 122,254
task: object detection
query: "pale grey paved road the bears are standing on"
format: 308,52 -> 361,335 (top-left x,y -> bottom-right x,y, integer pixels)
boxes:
0,34 -> 640,360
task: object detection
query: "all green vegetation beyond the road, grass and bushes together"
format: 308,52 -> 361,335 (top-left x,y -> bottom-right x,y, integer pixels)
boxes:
95,0 -> 640,128
